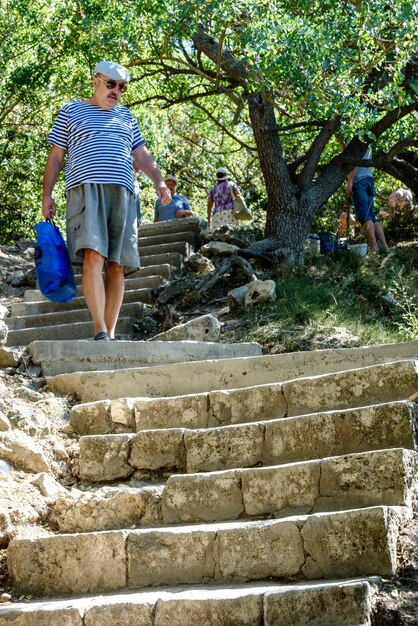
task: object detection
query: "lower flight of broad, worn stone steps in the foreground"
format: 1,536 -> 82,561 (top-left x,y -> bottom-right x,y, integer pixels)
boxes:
0,341 -> 418,626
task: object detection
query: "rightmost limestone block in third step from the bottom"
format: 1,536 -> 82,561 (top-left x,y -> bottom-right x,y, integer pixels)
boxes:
315,449 -> 418,511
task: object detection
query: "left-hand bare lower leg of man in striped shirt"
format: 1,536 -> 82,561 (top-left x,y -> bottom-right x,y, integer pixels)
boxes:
82,248 -> 108,336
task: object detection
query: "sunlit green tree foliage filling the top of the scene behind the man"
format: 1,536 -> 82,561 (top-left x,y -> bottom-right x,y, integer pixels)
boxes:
0,0 -> 417,242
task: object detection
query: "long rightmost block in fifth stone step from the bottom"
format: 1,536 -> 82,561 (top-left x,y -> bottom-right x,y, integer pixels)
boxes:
283,361 -> 418,415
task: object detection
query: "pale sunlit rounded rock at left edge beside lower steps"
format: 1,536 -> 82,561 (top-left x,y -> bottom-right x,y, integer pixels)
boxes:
0,430 -> 49,472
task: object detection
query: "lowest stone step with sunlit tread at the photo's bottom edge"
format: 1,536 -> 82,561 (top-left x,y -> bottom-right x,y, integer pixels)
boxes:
0,577 -> 380,626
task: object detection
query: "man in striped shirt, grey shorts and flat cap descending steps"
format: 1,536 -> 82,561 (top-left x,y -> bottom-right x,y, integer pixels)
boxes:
42,61 -> 171,341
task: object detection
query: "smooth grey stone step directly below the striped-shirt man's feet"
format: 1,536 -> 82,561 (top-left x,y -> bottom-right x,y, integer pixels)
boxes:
28,341 -> 262,372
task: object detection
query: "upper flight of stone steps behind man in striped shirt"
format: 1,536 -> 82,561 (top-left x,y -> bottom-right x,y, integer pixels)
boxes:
5,218 -> 201,346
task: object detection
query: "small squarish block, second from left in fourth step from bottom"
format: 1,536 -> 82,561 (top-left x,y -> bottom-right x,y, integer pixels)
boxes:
129,428 -> 186,470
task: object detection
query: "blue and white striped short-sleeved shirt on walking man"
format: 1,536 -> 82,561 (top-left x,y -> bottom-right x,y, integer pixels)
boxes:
48,102 -> 146,193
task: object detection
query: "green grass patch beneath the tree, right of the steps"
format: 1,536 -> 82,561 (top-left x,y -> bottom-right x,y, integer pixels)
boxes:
232,242 -> 418,353
